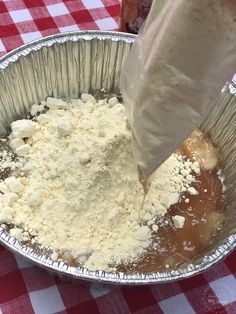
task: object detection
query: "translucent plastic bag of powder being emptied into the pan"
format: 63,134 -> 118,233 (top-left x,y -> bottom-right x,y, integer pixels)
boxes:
121,0 -> 236,190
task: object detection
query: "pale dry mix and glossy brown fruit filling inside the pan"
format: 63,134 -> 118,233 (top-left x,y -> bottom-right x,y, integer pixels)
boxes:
0,94 -> 224,273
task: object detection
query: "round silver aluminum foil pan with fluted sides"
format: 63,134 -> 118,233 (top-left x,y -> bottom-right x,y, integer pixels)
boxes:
0,31 -> 236,284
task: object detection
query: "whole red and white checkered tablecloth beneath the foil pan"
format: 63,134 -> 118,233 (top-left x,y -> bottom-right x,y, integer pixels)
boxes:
0,0 -> 236,314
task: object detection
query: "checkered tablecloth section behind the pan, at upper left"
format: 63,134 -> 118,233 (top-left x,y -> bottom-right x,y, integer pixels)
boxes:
0,0 -> 120,56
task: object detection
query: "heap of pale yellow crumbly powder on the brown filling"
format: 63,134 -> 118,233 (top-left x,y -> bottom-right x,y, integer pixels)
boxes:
0,94 -> 199,271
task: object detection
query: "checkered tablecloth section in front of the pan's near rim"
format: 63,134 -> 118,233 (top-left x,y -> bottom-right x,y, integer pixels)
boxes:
0,246 -> 236,314
